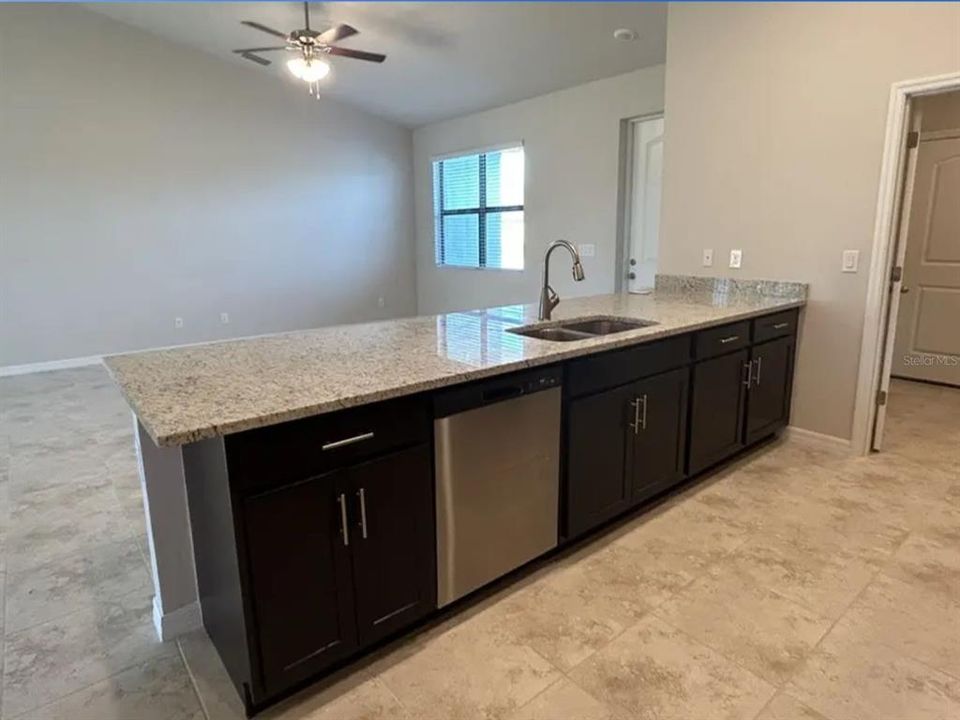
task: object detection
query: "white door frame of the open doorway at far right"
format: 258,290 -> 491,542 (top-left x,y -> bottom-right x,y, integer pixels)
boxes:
852,72 -> 960,455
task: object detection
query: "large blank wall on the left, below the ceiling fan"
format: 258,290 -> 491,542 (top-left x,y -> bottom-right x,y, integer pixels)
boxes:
0,5 -> 415,366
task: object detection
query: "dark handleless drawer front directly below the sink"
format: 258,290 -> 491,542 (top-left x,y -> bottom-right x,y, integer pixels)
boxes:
567,335 -> 690,396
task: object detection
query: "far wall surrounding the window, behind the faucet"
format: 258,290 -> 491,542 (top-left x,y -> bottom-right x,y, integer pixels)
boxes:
413,65 -> 670,313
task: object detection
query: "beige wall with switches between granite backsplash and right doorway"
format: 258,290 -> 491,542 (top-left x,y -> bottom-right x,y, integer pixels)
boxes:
660,3 -> 960,438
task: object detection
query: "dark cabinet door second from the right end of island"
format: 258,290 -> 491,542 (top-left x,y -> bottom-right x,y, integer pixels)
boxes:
687,350 -> 748,475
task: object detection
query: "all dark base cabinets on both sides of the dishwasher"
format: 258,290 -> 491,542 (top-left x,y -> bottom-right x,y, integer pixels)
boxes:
183,312 -> 796,712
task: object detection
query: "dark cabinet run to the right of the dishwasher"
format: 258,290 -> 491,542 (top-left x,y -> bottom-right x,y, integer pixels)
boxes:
561,311 -> 797,538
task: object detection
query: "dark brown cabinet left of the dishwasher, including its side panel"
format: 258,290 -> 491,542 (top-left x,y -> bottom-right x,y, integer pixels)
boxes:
183,397 -> 436,712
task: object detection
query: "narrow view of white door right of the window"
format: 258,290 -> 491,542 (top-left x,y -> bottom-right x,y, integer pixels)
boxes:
627,117 -> 663,292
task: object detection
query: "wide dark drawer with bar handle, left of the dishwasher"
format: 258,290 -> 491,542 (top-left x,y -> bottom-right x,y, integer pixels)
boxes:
224,396 -> 431,490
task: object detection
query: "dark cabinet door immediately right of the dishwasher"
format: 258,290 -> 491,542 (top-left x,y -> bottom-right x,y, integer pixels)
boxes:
566,386 -> 633,537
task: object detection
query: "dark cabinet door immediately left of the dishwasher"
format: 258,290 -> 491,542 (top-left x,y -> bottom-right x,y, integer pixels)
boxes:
348,445 -> 437,645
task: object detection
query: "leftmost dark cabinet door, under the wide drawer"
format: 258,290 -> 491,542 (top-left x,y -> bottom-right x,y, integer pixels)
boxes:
244,473 -> 357,694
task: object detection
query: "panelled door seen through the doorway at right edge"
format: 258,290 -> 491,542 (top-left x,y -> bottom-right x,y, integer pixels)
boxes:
891,137 -> 960,387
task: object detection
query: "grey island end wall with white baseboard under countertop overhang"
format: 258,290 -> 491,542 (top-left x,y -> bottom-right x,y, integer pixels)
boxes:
134,418 -> 201,640
